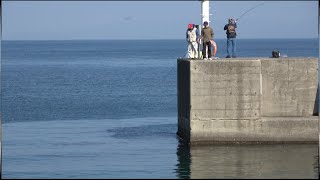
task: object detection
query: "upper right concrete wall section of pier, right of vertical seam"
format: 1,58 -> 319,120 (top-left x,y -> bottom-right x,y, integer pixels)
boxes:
261,58 -> 318,117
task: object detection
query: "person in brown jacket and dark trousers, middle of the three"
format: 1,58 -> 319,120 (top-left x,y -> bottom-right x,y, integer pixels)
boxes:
201,21 -> 214,60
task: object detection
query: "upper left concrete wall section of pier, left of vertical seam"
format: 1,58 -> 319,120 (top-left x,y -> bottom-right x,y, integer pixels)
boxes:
190,60 -> 261,120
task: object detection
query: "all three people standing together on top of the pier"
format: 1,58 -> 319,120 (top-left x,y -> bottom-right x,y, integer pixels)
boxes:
186,18 -> 237,60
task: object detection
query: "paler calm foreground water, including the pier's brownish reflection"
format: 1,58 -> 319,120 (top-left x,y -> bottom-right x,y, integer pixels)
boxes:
2,117 -> 318,179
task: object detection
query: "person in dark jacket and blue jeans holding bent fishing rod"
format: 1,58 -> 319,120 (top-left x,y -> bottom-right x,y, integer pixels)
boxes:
224,18 -> 237,58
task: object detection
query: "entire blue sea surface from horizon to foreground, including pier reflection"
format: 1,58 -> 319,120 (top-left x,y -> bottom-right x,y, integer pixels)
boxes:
1,39 -> 319,178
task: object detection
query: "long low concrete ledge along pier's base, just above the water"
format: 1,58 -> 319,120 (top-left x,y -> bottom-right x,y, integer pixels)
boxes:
190,117 -> 319,144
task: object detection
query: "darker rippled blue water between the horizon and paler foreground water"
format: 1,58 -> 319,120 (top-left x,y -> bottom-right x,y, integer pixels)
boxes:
2,39 -> 318,123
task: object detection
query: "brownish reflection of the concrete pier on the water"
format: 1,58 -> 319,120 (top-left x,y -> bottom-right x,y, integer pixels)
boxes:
176,143 -> 318,179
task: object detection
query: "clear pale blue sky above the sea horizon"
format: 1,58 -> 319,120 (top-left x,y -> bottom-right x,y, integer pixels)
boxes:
2,1 -> 319,40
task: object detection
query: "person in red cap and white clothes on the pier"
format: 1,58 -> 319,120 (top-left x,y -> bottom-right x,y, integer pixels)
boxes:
186,23 -> 199,59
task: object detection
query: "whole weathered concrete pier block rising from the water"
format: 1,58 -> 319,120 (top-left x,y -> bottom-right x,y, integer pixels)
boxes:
177,58 -> 319,144
